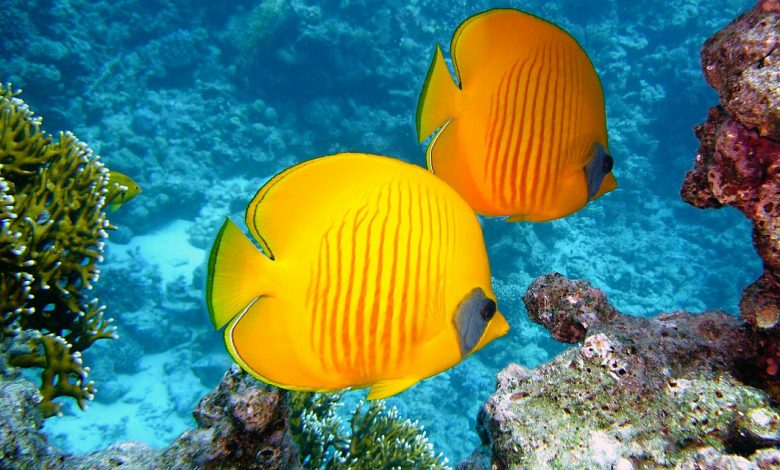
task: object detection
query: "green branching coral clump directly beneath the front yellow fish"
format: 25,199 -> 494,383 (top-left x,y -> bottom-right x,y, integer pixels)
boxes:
289,392 -> 447,469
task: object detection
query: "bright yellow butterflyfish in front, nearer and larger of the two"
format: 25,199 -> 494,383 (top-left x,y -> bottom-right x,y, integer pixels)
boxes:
206,154 -> 509,399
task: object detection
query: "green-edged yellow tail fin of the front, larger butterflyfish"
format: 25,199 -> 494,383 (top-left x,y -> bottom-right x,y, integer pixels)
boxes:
206,219 -> 273,329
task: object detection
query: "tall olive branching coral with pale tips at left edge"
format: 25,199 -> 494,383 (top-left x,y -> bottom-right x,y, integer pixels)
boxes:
0,85 -> 122,416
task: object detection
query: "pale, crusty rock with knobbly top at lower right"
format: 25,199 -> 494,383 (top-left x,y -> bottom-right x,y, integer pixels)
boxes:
459,273 -> 780,468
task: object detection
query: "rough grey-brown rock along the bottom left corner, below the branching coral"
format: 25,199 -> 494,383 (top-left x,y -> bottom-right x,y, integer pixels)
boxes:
0,366 -> 300,469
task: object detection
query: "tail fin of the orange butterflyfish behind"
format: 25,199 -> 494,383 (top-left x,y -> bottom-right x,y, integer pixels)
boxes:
417,44 -> 460,143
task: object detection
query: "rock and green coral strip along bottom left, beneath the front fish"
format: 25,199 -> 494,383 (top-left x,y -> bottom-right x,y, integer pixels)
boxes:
0,365 -> 446,470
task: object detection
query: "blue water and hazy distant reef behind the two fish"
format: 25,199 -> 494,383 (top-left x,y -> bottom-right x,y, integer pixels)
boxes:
0,0 -> 761,462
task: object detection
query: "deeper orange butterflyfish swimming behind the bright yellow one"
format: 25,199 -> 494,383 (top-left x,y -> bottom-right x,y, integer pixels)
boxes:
417,9 -> 617,222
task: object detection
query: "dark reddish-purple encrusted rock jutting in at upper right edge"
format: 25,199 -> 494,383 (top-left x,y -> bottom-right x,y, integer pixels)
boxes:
681,0 -> 780,329
